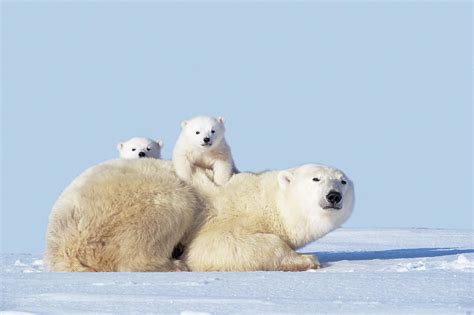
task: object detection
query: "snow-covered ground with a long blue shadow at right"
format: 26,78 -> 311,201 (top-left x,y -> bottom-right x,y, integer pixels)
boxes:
0,229 -> 474,314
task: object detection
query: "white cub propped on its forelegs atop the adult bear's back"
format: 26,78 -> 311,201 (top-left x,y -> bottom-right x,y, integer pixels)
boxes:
173,116 -> 237,186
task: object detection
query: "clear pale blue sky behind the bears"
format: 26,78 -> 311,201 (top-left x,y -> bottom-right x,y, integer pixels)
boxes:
1,1 -> 473,252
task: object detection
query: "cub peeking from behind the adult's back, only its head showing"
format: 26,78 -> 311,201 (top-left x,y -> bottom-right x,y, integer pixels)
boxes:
117,137 -> 163,159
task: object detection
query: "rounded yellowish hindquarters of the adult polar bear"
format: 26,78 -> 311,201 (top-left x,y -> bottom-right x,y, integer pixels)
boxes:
44,159 -> 203,271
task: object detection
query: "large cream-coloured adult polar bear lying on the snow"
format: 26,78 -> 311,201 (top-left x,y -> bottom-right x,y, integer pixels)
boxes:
45,159 -> 354,271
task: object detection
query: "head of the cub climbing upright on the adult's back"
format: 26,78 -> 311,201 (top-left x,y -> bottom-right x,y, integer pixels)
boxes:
181,116 -> 225,150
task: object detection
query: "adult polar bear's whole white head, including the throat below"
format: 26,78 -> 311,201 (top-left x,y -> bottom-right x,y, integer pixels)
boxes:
277,164 -> 354,247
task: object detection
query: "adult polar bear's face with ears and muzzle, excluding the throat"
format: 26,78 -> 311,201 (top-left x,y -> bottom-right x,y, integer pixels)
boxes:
278,164 -> 354,224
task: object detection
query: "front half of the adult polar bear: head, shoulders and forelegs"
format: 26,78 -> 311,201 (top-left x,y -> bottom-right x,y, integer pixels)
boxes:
182,164 -> 354,271
